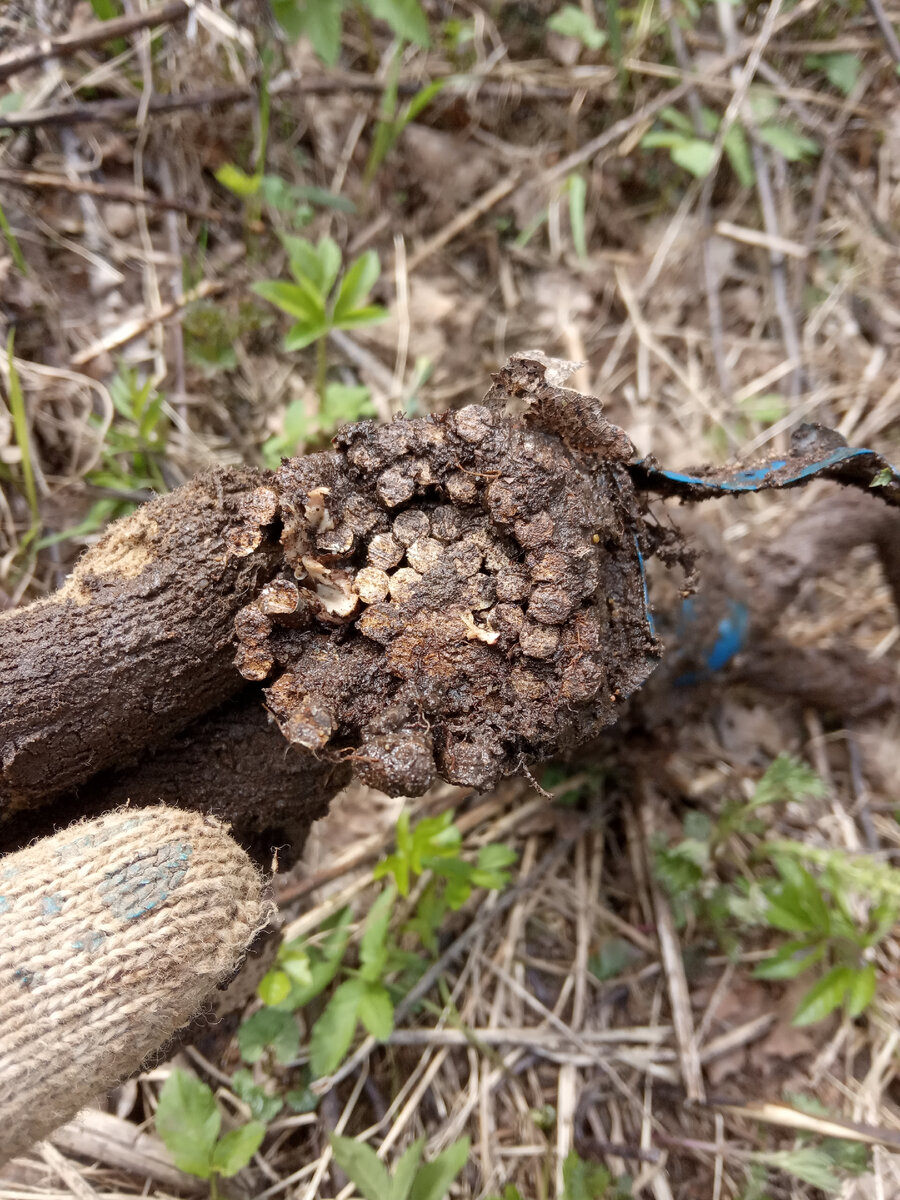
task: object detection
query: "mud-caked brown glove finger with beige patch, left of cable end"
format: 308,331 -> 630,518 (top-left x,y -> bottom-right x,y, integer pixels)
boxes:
0,469 -> 277,811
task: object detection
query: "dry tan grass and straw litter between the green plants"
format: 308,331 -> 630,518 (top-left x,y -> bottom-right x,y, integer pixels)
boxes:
0,0 -> 900,1200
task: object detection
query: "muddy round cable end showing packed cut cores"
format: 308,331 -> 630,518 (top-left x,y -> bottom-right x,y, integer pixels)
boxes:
235,354 -> 660,794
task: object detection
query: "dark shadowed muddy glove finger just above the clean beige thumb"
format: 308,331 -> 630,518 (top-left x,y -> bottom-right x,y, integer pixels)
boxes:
0,688 -> 350,870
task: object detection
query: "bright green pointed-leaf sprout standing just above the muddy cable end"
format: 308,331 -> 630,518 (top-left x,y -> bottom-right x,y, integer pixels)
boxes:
253,234 -> 388,403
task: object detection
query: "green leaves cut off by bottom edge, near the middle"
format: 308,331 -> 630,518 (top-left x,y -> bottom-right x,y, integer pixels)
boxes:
329,1134 -> 470,1200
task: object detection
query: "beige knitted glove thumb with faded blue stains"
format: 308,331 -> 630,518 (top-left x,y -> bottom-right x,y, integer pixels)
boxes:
0,806 -> 268,1164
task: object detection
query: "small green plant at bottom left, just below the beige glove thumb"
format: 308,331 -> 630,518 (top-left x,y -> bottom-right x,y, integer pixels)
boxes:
156,1068 -> 265,1198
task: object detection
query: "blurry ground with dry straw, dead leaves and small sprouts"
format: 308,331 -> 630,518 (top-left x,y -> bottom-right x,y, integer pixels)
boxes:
0,0 -> 900,1200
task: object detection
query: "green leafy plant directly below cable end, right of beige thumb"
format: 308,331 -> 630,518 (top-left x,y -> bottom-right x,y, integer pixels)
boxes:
238,812 -> 516,1078
